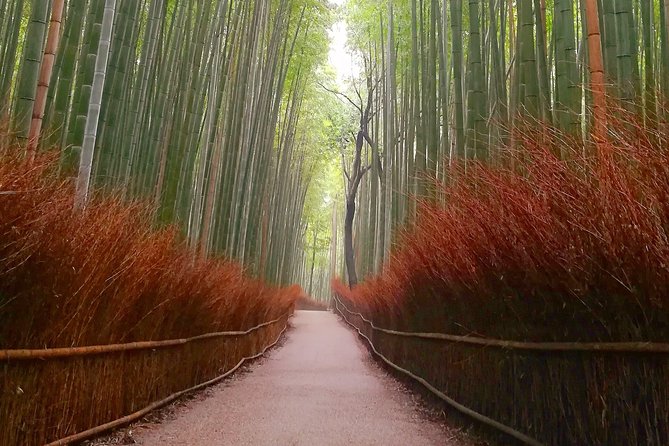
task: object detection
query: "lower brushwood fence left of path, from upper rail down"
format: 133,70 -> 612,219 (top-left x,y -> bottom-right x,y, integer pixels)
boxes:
0,315 -> 289,446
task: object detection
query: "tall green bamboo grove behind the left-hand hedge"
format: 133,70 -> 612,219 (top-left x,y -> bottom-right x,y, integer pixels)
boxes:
0,0 -> 332,283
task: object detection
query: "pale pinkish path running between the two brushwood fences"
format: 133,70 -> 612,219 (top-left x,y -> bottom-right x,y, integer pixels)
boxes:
134,311 -> 466,446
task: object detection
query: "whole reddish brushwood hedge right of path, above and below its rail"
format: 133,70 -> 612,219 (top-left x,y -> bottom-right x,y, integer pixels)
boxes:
334,111 -> 669,445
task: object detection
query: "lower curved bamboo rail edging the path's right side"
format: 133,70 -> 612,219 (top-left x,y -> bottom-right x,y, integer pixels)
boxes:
335,298 -> 543,446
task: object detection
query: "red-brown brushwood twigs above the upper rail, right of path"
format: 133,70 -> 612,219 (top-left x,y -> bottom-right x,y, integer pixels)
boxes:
335,114 -> 669,341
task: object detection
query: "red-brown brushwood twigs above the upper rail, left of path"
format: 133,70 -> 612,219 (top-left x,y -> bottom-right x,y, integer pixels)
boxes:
0,155 -> 301,348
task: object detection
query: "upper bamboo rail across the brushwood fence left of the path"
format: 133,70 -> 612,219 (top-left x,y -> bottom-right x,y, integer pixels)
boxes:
0,314 -> 287,361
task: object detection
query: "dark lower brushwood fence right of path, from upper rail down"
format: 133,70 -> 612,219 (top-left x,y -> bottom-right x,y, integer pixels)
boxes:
335,297 -> 669,446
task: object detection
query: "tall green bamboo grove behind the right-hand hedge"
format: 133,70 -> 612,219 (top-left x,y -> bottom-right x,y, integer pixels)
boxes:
336,0 -> 669,276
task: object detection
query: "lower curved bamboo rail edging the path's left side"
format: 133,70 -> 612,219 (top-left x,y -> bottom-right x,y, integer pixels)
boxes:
46,316 -> 288,446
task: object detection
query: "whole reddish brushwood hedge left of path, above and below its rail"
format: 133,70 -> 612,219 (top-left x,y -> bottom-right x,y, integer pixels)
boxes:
0,145 -> 302,445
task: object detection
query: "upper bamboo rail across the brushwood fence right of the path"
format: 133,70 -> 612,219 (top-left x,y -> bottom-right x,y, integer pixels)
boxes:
334,295 -> 669,354
